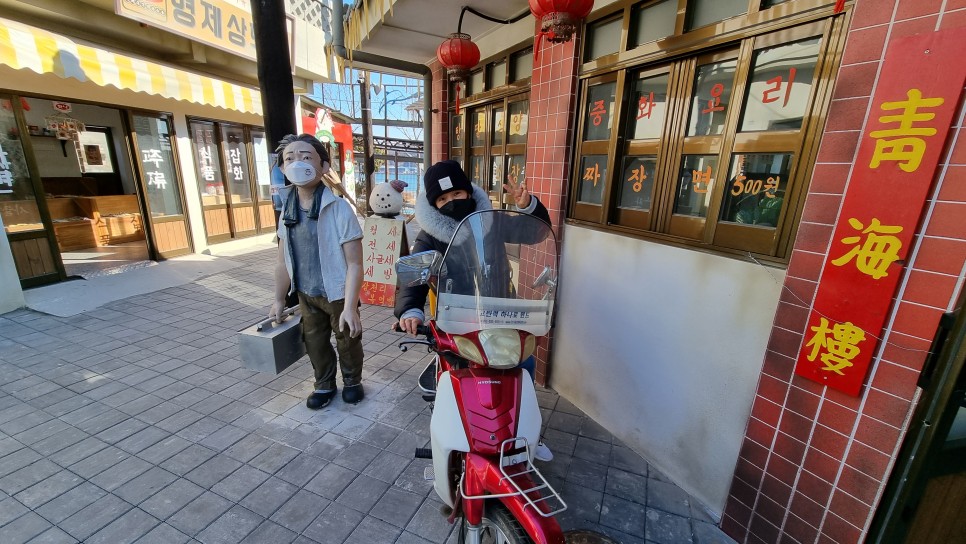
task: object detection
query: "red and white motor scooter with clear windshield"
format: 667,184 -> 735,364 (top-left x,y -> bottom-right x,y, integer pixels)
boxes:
396,210 -> 567,544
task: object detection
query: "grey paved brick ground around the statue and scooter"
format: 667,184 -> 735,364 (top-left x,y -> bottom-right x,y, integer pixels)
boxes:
0,249 -> 731,544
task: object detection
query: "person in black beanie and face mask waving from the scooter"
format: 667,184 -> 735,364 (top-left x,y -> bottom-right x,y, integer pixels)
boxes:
394,160 -> 553,461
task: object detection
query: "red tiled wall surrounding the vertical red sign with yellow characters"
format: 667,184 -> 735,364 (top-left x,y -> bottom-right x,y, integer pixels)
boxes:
722,0 -> 966,544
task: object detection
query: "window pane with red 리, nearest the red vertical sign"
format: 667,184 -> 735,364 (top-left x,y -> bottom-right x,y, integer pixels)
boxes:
740,38 -> 821,132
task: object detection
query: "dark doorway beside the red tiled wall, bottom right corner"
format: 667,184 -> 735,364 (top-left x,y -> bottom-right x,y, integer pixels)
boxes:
869,290 -> 966,544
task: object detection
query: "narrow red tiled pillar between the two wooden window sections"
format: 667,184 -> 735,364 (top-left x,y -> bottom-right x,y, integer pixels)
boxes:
527,22 -> 581,384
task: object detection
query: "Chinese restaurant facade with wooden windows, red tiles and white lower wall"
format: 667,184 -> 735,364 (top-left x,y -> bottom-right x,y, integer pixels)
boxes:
347,0 -> 966,543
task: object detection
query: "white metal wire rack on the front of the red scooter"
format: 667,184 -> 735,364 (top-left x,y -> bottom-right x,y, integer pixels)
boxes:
459,438 -> 567,518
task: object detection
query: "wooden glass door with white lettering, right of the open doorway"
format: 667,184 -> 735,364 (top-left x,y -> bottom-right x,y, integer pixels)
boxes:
130,114 -> 191,258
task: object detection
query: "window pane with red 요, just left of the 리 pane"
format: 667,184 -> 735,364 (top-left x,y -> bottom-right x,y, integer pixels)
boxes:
688,60 -> 738,136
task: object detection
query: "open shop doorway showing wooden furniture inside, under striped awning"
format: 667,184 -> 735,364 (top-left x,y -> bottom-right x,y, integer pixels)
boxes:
22,98 -> 153,278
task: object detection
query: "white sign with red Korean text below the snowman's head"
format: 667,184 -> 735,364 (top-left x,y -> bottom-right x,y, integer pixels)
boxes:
360,216 -> 409,307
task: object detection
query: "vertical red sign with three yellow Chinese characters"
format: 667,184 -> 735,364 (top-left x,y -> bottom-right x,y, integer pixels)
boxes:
795,31 -> 966,396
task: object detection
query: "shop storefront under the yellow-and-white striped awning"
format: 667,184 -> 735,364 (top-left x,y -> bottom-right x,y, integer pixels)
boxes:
0,14 -> 271,287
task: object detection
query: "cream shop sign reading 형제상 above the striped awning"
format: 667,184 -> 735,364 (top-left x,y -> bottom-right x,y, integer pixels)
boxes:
114,0 -> 255,60
